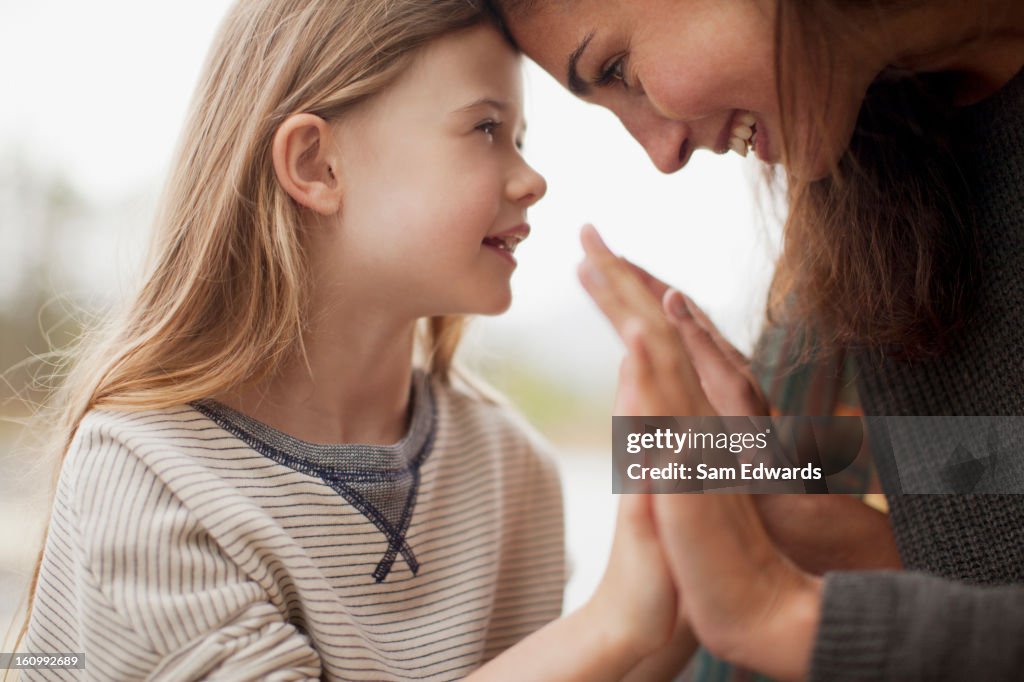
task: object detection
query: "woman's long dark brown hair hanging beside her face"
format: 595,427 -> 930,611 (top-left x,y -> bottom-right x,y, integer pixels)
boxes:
492,0 -> 978,359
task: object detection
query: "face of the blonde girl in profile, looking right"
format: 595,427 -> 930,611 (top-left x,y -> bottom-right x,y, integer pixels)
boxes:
330,26 -> 546,316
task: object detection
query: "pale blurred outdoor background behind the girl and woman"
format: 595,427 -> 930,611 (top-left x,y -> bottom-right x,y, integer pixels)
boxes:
0,0 -> 779,632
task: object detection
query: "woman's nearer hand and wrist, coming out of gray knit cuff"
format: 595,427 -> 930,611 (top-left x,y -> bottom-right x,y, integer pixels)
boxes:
580,228 -> 820,679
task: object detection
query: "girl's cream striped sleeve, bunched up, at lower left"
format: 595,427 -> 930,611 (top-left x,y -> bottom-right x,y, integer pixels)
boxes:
32,419 -> 321,680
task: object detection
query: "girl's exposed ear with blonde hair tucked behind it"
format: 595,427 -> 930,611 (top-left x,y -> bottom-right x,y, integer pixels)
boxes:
271,114 -> 341,215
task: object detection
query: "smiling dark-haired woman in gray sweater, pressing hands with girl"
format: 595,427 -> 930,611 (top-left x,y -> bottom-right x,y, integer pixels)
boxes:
489,0 -> 1024,680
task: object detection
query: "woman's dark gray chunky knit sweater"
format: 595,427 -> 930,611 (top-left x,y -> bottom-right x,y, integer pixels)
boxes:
810,66 -> 1024,682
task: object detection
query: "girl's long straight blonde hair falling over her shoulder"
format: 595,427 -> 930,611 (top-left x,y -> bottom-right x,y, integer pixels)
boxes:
9,0 -> 486,655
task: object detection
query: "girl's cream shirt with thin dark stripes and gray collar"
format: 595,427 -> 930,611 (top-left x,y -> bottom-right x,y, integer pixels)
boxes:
26,372 -> 564,680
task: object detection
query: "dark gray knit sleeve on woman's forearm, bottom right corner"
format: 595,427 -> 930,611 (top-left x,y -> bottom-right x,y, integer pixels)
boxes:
809,571 -> 1024,682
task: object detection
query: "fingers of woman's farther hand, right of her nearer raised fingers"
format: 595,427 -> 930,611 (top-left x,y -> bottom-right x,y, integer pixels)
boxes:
663,289 -> 769,417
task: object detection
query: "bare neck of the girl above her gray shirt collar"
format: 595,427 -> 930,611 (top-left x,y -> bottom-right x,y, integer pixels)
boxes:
219,312 -> 415,444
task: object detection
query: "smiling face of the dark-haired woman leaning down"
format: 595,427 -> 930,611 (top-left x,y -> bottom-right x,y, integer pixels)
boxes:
509,0 -> 869,176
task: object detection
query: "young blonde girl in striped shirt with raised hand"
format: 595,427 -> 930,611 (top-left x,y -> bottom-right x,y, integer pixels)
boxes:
24,0 -> 688,680
